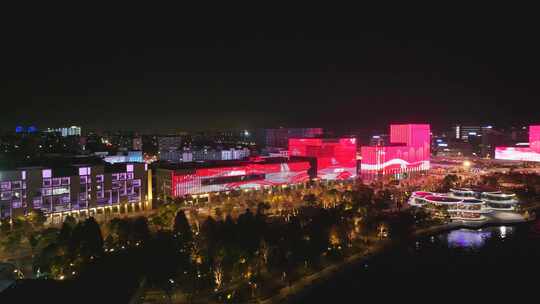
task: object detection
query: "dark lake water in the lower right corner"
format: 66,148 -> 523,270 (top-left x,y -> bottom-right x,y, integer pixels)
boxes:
298,221 -> 540,303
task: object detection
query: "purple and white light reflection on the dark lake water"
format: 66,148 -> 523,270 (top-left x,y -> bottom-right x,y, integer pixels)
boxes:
446,226 -> 514,249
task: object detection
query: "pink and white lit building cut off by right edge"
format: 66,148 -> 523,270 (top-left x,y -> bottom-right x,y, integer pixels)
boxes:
495,125 -> 540,162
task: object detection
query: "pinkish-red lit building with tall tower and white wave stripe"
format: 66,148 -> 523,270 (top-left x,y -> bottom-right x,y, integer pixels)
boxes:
360,124 -> 431,175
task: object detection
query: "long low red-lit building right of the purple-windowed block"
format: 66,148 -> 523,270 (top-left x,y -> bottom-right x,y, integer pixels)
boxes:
154,158 -> 310,199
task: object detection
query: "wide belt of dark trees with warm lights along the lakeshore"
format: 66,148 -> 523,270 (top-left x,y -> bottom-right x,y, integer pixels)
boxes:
2,179 -> 434,301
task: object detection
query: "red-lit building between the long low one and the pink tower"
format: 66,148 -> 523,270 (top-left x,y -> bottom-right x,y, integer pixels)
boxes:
289,137 -> 357,180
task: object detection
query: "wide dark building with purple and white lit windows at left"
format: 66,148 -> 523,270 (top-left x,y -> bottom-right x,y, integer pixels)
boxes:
0,163 -> 147,218
